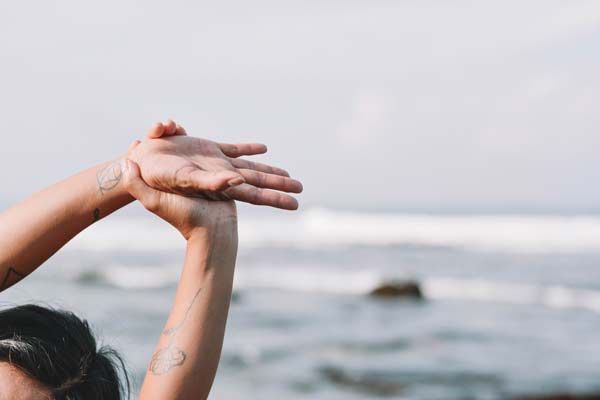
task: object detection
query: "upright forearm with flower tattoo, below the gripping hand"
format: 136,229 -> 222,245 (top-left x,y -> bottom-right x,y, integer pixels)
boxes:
140,223 -> 237,400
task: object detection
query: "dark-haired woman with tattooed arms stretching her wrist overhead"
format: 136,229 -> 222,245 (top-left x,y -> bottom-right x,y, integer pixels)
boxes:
0,121 -> 302,400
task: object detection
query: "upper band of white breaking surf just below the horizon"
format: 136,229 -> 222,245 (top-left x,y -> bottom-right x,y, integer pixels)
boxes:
70,209 -> 600,253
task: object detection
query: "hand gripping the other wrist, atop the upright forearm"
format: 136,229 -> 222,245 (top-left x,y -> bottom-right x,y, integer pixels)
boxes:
121,159 -> 237,240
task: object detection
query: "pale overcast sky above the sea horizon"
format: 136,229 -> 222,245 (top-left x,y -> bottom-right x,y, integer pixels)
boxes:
0,0 -> 600,210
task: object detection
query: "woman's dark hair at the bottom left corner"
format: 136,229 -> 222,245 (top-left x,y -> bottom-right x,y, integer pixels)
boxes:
0,304 -> 130,400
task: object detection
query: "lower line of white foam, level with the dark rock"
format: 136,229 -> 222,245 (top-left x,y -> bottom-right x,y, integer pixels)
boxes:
90,265 -> 600,313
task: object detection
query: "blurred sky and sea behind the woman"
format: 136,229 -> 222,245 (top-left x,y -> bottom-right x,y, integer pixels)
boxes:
0,0 -> 600,400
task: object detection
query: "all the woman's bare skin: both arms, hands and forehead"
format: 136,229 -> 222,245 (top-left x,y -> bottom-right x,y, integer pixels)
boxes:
0,121 -> 302,400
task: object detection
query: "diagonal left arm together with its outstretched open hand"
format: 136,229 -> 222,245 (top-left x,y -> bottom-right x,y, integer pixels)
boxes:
0,121 -> 302,292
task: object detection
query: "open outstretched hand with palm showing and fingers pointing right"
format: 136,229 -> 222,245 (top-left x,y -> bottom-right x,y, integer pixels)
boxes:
128,121 -> 302,210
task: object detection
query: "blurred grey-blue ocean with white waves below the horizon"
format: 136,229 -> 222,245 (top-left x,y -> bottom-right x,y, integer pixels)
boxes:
0,208 -> 600,400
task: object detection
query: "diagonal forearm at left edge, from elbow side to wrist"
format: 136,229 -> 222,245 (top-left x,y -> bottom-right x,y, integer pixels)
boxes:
0,159 -> 133,291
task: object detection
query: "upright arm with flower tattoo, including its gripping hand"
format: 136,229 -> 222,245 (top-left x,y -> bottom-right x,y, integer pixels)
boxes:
124,162 -> 238,400
